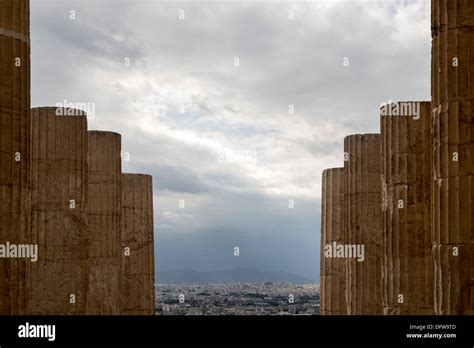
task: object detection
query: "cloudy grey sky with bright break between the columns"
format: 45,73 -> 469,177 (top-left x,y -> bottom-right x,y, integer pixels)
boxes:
31,0 -> 430,280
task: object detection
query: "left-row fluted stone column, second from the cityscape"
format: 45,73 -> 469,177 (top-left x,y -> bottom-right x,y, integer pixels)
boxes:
86,131 -> 122,314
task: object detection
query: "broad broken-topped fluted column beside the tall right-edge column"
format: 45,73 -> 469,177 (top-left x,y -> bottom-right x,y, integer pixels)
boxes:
380,102 -> 434,315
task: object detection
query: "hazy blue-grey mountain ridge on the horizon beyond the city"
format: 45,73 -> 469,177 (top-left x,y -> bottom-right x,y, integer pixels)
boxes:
156,267 -> 315,284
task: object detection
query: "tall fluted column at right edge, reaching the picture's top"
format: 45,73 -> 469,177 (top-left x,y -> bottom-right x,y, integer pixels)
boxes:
431,0 -> 474,314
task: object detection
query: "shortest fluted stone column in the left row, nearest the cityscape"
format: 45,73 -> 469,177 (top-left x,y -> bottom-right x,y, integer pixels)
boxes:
120,174 -> 155,315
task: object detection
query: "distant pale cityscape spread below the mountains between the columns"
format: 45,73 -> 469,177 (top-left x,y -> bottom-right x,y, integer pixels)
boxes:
155,282 -> 319,315
